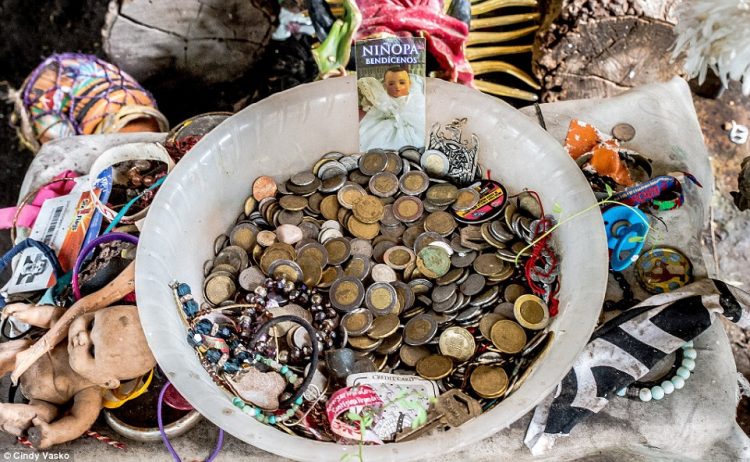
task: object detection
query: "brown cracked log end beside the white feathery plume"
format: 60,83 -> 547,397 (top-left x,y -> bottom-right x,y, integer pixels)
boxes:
533,0 -> 682,101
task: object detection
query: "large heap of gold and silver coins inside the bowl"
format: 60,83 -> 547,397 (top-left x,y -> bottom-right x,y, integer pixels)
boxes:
203,147 -> 551,434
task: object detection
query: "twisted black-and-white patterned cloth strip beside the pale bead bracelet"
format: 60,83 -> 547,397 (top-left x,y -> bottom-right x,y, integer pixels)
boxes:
524,279 -> 750,454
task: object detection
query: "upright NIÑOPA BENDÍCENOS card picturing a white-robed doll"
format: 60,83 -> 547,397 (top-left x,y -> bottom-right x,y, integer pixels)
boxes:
355,37 -> 427,152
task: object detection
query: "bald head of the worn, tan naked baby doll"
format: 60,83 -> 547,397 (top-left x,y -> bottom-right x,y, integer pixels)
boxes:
68,305 -> 156,388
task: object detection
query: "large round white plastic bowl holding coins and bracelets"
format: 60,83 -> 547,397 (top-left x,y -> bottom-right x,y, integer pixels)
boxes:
136,77 -> 608,462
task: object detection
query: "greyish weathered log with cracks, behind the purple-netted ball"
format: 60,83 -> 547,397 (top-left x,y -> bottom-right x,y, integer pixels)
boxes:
102,0 -> 278,83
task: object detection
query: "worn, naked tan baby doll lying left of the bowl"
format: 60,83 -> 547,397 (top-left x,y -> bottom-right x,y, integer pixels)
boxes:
0,304 -> 156,449
